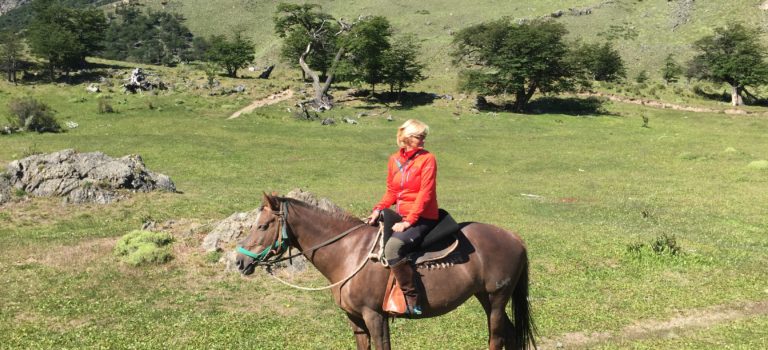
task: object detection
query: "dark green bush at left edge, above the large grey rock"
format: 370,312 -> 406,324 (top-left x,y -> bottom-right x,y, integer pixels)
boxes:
8,97 -> 61,132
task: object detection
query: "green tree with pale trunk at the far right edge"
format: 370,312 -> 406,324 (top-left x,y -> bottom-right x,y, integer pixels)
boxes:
689,24 -> 768,106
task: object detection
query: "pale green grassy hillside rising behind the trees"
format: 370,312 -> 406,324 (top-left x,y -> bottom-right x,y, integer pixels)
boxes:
135,0 -> 768,86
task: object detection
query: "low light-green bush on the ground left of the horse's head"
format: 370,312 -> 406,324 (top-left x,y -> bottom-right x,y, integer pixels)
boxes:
114,230 -> 173,266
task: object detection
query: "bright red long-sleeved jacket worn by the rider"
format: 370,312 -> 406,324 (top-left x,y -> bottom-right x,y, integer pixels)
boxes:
374,148 -> 438,225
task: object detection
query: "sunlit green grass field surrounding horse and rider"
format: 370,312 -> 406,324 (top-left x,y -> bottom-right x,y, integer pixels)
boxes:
0,58 -> 768,349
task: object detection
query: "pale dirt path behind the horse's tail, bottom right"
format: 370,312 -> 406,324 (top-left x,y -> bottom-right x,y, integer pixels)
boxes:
538,300 -> 768,349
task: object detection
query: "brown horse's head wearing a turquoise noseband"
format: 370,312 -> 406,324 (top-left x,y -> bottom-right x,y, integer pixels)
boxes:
236,193 -> 288,275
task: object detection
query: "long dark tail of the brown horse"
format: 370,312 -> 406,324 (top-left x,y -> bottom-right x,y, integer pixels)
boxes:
512,251 -> 536,349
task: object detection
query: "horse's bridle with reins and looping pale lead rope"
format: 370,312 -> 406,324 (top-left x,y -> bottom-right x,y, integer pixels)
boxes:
237,202 -> 376,291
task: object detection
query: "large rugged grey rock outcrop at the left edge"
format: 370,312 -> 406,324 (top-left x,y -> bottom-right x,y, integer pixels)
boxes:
0,149 -> 176,204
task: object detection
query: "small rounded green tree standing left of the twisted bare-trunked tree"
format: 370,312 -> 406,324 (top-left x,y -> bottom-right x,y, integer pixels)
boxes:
206,32 -> 254,78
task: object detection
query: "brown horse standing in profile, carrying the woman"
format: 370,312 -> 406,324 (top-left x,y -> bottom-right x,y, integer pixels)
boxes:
237,194 -> 536,350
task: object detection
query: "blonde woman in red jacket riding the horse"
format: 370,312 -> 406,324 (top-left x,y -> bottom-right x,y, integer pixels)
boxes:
368,119 -> 438,315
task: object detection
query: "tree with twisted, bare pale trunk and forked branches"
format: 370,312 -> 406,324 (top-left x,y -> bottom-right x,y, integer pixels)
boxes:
274,3 -> 355,111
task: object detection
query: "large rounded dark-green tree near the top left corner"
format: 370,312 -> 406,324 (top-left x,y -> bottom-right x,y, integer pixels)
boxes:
28,0 -> 107,79
